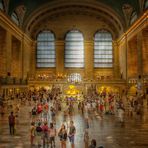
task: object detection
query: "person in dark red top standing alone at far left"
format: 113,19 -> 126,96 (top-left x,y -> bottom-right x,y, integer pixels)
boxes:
8,112 -> 15,135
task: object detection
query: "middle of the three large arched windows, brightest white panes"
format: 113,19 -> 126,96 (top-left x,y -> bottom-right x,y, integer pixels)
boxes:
65,30 -> 84,68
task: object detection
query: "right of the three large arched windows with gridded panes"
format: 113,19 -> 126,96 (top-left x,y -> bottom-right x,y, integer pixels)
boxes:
94,30 -> 113,68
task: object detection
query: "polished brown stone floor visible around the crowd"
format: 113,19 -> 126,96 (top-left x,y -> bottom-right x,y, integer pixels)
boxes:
0,101 -> 148,148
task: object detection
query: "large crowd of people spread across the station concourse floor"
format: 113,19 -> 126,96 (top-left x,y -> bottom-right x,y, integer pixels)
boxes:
0,86 -> 147,148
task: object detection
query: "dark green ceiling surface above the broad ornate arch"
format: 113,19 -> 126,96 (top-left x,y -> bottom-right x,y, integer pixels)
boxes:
9,0 -> 140,16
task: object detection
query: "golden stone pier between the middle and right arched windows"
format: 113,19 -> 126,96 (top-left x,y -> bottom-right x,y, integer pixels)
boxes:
84,41 -> 94,79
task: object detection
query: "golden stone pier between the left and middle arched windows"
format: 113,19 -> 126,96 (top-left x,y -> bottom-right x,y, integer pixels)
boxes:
55,41 -> 64,74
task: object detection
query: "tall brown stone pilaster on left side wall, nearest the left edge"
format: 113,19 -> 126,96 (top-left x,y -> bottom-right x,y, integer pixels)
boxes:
5,31 -> 12,73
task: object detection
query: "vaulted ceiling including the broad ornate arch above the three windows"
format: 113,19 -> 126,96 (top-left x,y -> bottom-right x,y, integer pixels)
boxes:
4,0 -> 145,38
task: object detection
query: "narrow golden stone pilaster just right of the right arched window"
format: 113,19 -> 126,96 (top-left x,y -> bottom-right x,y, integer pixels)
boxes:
113,41 -> 121,79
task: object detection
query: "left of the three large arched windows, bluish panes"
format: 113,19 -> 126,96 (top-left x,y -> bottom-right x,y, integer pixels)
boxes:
37,31 -> 56,68
